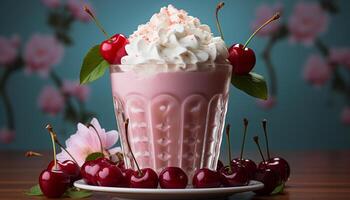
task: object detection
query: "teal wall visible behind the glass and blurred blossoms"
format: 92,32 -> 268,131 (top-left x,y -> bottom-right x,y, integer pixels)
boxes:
0,0 -> 350,150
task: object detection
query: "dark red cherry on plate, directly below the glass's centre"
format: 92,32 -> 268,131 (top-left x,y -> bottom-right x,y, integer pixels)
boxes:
159,167 -> 188,189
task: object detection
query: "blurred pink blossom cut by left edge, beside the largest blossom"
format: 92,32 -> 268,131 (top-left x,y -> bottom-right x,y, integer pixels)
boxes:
0,35 -> 20,66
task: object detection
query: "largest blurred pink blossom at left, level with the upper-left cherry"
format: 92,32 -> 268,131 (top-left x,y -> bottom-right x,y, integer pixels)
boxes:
23,34 -> 64,77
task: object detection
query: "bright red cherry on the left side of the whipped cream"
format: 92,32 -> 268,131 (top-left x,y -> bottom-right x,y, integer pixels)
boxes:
100,34 -> 129,64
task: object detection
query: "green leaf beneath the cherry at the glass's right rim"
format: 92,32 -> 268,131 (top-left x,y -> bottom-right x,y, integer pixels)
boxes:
231,72 -> 268,100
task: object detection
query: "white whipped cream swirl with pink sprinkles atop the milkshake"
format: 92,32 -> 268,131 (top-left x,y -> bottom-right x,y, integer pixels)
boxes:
120,5 -> 228,73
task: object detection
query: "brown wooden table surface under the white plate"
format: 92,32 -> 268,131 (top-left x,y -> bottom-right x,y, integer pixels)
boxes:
0,151 -> 350,200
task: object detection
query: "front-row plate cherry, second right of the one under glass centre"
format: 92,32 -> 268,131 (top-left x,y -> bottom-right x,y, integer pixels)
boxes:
219,165 -> 249,187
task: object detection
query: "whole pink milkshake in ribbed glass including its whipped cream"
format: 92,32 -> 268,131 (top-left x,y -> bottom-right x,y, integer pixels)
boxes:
110,5 -> 232,177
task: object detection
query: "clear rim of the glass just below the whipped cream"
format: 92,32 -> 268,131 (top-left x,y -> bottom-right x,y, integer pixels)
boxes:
109,63 -> 232,73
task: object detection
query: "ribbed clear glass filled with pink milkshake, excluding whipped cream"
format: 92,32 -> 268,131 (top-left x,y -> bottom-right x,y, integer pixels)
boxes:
110,64 -> 232,178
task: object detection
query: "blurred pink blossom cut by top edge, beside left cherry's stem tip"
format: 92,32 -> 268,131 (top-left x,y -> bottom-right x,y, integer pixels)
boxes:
67,0 -> 94,22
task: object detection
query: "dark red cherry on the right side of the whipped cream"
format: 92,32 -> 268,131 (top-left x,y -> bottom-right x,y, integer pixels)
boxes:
228,44 -> 256,75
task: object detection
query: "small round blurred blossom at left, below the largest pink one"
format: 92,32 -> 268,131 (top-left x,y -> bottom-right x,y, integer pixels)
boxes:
38,86 -> 64,116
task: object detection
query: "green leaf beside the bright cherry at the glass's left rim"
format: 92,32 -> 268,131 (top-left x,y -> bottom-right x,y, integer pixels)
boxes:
80,45 -> 109,84
